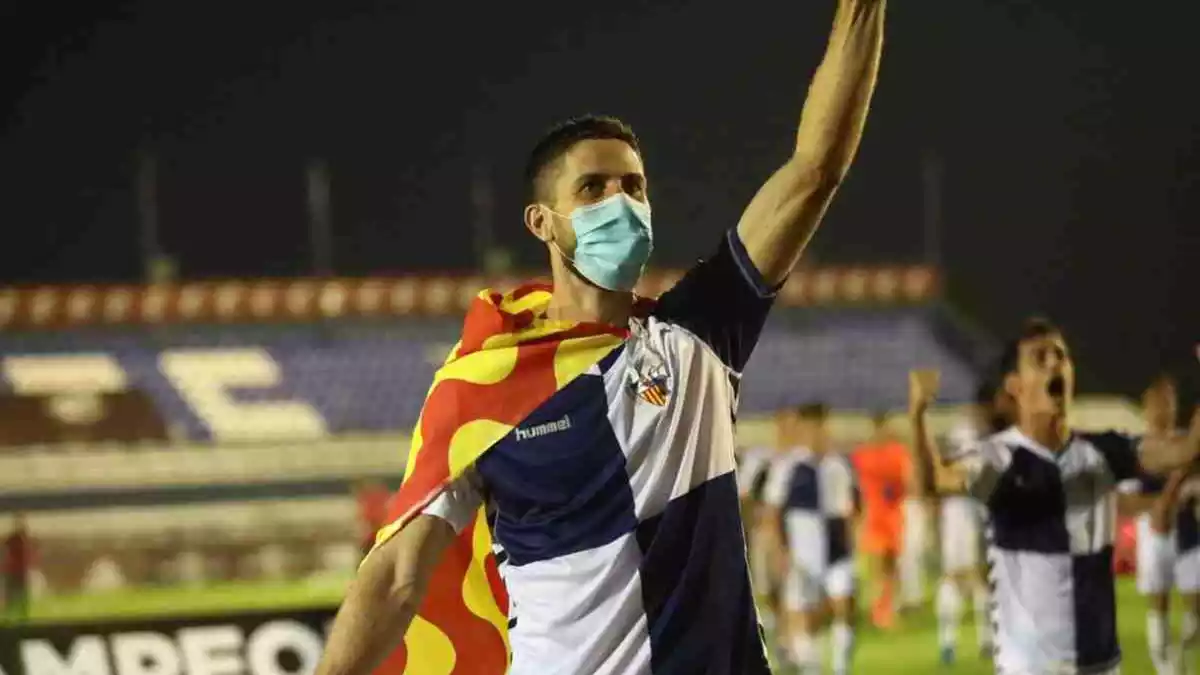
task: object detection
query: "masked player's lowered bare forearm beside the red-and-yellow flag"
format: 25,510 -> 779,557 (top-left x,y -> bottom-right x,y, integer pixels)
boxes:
316,515 -> 455,675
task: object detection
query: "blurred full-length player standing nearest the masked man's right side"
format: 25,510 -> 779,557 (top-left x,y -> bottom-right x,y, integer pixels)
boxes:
763,404 -> 857,675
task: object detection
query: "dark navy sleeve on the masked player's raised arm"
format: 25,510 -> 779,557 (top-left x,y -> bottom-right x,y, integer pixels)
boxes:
653,229 -> 779,372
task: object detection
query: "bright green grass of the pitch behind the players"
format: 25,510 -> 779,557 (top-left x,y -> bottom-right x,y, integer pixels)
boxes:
7,569 -> 1178,675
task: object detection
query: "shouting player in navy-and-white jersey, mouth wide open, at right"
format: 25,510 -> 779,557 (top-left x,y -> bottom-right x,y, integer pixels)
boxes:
944,319 -> 1200,675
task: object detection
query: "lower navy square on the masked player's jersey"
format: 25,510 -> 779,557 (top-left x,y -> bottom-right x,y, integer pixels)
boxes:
637,473 -> 770,675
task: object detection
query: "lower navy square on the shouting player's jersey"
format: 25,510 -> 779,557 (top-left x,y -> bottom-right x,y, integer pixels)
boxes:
1070,546 -> 1121,668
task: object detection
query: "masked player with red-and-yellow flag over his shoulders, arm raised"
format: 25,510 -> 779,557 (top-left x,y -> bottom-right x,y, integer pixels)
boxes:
317,0 -> 886,675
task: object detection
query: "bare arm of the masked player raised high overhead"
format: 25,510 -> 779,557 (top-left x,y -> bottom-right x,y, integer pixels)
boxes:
738,0 -> 887,286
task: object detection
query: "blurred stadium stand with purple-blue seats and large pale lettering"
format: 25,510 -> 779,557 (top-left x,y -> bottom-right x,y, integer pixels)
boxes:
0,268 -> 986,592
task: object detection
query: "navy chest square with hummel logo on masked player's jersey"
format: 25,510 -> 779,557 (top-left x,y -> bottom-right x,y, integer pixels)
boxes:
475,347 -> 637,566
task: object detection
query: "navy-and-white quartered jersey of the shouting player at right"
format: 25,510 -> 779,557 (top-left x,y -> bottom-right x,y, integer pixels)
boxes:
952,428 -> 1139,675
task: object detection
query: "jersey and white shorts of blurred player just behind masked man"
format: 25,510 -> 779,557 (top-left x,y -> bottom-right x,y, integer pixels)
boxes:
763,448 -> 857,611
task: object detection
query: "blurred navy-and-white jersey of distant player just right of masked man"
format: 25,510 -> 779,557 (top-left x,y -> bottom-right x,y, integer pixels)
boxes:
763,448 -> 856,573
